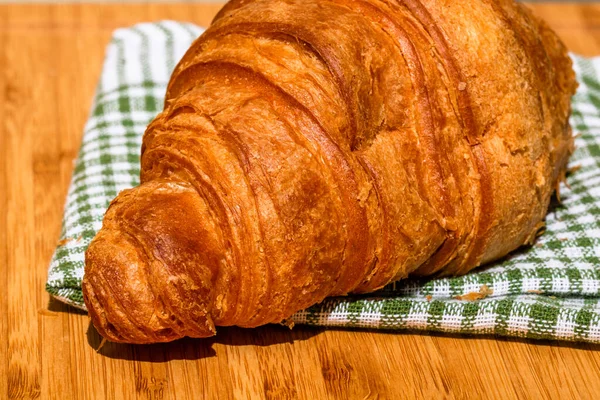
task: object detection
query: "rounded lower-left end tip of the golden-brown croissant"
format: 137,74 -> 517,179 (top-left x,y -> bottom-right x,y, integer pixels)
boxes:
82,182 -> 223,344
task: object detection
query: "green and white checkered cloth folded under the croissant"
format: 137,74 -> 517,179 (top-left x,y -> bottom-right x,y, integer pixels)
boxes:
46,21 -> 600,342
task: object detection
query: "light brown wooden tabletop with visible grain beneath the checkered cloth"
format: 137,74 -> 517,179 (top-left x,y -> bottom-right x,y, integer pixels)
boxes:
0,3 -> 600,399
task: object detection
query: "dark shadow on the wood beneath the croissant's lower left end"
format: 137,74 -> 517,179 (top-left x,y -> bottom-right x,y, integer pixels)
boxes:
87,322 -> 325,362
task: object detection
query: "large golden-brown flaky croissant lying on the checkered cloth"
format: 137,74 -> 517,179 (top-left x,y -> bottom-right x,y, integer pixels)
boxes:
82,0 -> 577,343
